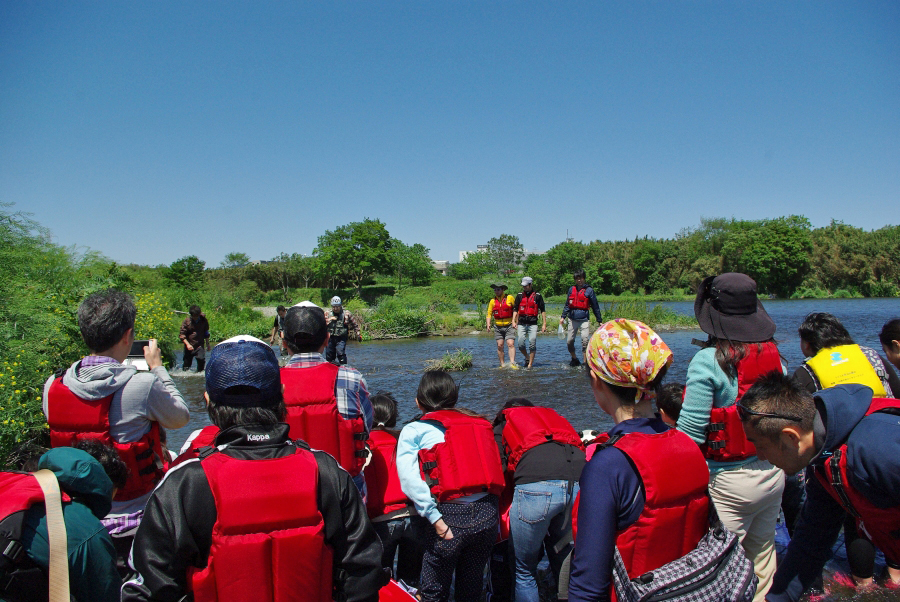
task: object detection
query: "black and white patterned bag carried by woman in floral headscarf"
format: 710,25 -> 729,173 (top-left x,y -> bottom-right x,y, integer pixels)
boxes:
613,507 -> 759,602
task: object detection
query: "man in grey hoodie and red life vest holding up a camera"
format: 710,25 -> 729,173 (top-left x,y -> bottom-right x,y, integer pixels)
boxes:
43,289 -> 190,556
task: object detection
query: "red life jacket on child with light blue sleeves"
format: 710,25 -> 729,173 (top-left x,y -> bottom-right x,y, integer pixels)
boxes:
419,410 -> 505,502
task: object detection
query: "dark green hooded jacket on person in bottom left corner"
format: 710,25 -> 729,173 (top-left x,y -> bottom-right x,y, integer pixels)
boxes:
9,447 -> 122,602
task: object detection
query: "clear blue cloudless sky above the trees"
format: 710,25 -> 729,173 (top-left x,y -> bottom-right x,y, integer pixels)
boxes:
0,1 -> 900,266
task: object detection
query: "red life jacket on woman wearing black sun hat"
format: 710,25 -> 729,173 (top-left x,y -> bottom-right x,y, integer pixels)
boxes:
700,343 -> 781,462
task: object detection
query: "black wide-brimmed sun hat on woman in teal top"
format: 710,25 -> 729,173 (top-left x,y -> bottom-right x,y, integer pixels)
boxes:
694,272 -> 775,343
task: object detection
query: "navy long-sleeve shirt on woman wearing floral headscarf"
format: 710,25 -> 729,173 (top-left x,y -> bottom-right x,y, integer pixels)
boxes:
569,418 -> 669,602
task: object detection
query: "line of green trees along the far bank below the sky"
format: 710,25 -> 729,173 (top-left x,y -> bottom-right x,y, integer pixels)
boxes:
164,215 -> 900,298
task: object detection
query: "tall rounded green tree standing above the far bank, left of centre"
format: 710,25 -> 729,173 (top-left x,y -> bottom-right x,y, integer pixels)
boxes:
315,218 -> 391,294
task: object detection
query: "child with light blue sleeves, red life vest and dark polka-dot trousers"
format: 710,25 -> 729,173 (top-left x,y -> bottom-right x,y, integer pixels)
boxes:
397,370 -> 504,601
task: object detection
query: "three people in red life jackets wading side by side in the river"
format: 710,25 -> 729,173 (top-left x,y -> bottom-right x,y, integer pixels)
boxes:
485,269 -> 603,369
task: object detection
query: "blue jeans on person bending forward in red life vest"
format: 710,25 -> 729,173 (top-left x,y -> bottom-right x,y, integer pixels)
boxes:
509,480 -> 578,602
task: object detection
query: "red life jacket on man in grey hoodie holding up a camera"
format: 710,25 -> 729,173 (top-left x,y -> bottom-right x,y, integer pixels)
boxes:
47,377 -> 165,501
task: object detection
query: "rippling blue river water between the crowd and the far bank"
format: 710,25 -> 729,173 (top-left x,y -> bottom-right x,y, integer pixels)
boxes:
169,299 -> 900,449
